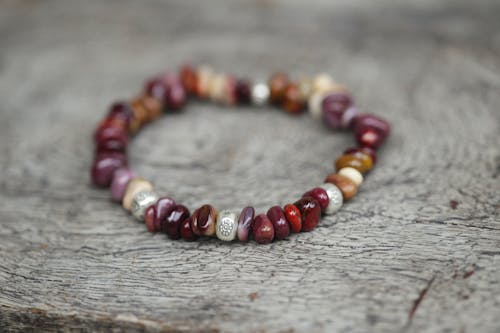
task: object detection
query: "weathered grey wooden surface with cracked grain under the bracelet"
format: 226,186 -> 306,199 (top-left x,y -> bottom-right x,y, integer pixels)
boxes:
0,0 -> 500,332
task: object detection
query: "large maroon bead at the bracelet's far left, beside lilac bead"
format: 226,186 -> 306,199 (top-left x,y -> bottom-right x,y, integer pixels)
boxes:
90,153 -> 127,187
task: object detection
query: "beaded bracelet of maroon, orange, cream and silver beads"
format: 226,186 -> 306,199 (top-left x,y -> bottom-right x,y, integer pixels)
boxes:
91,65 -> 390,244
